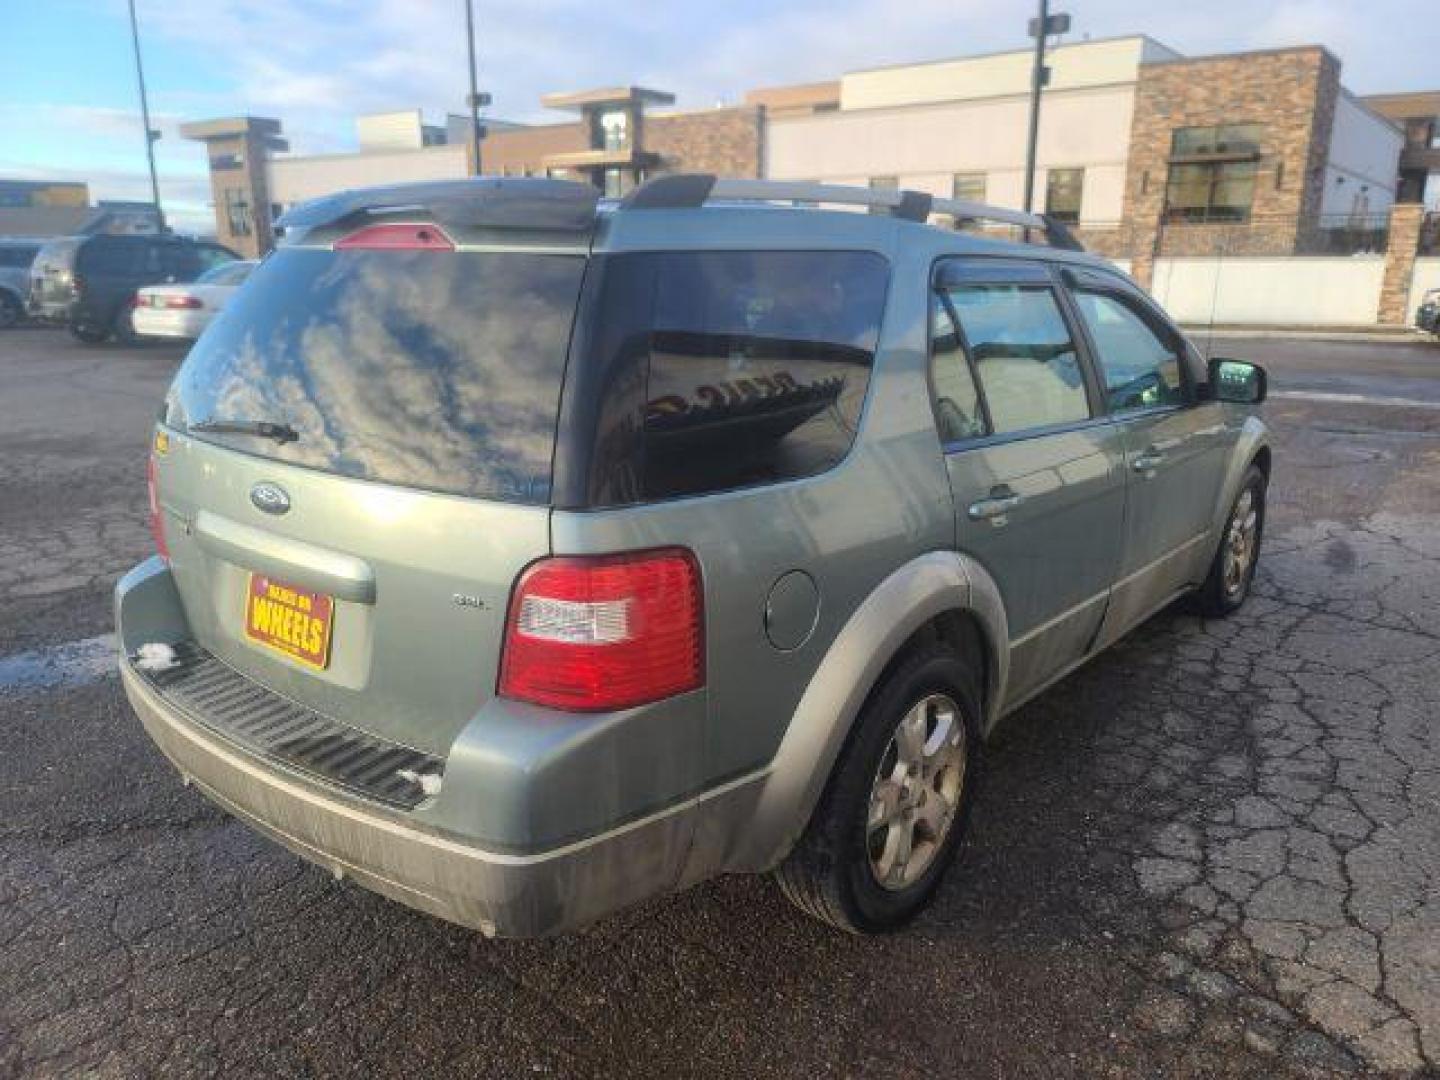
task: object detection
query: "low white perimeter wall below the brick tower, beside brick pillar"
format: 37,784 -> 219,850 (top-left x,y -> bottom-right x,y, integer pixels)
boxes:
1151,255 -> 1385,325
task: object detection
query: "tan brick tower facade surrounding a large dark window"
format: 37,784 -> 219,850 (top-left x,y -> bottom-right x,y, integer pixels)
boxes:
1125,46 -> 1341,282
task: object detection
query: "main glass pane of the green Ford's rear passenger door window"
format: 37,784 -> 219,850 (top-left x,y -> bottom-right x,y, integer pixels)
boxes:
948,285 -> 1090,435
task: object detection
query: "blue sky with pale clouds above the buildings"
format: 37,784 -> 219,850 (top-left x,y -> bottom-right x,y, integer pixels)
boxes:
0,0 -> 1440,228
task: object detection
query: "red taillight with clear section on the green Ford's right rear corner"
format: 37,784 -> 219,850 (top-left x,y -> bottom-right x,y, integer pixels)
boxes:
500,547 -> 706,713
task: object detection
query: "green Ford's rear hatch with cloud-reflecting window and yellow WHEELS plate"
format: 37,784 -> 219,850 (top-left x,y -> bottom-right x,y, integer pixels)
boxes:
156,236 -> 586,755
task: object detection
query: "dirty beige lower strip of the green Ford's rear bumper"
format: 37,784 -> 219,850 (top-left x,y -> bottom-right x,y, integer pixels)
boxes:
121,660 -> 700,936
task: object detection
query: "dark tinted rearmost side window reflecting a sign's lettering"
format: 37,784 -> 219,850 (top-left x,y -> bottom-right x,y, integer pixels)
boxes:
642,252 -> 888,498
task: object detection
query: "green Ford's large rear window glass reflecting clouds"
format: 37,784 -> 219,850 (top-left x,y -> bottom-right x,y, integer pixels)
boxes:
164,248 -> 585,503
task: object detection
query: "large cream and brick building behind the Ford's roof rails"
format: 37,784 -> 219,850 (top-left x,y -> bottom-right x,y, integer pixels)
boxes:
749,36 -> 1403,247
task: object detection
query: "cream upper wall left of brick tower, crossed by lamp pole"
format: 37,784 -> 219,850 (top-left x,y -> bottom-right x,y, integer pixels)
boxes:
765,85 -> 1135,223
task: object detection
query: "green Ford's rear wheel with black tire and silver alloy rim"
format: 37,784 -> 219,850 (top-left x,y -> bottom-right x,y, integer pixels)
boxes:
775,642 -> 981,933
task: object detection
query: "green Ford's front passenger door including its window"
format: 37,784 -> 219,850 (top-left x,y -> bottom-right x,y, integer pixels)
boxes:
1064,271 -> 1228,645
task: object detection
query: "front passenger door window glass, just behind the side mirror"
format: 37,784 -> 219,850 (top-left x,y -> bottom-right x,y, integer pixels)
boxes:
1074,289 -> 1187,412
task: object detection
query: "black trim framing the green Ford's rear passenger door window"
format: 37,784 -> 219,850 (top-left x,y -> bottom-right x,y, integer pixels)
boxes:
924,255 -> 1112,456
